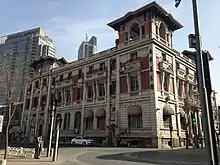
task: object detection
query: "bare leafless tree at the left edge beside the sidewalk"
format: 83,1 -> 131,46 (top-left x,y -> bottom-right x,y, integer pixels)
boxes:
0,56 -> 20,160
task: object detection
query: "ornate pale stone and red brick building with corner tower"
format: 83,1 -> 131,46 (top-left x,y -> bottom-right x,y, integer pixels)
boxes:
21,2 -> 201,147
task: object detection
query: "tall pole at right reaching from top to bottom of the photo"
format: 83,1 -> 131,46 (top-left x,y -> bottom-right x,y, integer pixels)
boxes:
192,0 -> 218,165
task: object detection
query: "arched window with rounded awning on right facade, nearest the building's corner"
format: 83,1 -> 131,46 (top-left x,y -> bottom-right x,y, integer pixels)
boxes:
163,105 -> 174,128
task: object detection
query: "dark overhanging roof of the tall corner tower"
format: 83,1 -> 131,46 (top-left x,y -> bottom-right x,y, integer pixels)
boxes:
108,1 -> 183,31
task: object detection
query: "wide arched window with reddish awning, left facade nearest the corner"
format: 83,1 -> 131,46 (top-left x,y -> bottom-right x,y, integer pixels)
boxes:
128,105 -> 143,128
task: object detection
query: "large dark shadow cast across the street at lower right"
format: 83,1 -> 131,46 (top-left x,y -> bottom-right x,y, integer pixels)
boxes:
97,149 -> 220,165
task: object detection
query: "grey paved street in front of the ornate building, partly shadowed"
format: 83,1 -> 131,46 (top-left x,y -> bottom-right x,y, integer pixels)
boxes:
5,147 -> 220,165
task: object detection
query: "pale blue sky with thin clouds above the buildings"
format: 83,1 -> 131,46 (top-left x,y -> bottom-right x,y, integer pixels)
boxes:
0,0 -> 220,103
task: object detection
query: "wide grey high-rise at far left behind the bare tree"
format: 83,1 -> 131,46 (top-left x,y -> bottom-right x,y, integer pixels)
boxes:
0,28 -> 55,105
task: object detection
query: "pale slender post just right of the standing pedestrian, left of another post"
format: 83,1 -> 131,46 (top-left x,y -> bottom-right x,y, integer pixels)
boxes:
47,98 -> 57,157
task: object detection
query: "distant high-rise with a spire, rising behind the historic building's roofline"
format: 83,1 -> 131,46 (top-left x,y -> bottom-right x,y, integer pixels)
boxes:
78,35 -> 97,60
